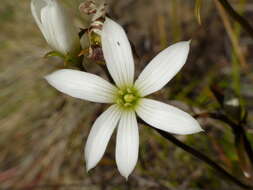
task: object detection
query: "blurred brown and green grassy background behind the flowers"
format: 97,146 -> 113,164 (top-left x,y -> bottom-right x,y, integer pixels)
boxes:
0,0 -> 253,190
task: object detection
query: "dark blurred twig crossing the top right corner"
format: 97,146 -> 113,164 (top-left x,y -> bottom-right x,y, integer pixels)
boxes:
216,0 -> 253,38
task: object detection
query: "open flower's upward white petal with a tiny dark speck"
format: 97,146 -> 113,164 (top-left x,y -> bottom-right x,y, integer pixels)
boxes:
102,18 -> 134,87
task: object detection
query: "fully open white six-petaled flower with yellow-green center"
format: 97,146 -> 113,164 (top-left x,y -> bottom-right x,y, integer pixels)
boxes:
46,18 -> 202,178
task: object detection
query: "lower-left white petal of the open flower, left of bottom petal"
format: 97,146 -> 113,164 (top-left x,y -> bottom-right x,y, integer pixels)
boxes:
85,105 -> 121,171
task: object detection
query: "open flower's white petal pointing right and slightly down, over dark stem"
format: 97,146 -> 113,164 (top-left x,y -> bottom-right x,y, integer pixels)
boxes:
136,98 -> 203,135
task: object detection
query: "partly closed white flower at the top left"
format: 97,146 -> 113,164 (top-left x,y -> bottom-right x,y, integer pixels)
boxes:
31,0 -> 80,55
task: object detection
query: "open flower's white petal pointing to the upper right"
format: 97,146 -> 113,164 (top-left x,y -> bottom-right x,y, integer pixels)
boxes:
135,41 -> 190,96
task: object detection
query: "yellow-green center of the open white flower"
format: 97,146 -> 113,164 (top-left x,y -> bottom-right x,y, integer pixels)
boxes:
116,87 -> 140,109
